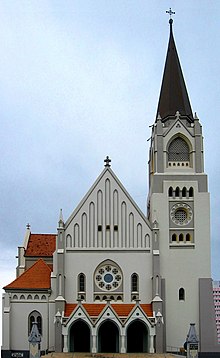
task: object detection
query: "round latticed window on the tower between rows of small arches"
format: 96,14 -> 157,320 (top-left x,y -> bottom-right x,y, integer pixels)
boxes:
170,203 -> 193,226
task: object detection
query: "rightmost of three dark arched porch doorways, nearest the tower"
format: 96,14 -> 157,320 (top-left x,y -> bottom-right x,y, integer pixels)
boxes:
127,320 -> 148,353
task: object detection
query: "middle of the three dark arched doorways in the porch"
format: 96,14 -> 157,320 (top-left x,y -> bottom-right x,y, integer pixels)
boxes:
98,321 -> 119,353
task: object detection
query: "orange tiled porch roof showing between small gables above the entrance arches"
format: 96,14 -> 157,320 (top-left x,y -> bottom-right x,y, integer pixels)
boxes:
65,303 -> 153,317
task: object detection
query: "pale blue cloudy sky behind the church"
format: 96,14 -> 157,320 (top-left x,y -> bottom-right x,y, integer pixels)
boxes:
0,0 -> 220,346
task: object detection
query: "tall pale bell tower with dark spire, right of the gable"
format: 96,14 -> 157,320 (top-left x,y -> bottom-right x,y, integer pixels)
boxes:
148,14 -> 217,347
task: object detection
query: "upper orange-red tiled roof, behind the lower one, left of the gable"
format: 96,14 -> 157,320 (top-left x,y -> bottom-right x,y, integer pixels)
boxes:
25,234 -> 56,257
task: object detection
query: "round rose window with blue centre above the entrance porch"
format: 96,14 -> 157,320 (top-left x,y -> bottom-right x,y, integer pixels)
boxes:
95,265 -> 122,291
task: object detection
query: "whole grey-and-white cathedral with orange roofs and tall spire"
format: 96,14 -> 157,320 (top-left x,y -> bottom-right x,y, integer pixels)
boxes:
1,19 -> 218,358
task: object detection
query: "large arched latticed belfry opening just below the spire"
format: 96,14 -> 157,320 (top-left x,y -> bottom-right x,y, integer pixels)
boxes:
168,137 -> 189,162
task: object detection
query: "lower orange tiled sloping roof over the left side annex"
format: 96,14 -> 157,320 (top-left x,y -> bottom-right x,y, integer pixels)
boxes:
4,259 -> 51,289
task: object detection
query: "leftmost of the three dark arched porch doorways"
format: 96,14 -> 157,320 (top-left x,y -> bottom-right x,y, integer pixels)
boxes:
70,320 -> 90,352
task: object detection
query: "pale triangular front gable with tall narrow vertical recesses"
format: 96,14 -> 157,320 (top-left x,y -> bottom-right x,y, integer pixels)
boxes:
65,168 -> 151,250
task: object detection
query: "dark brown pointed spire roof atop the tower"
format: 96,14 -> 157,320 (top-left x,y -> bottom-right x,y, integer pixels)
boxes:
157,19 -> 193,121
